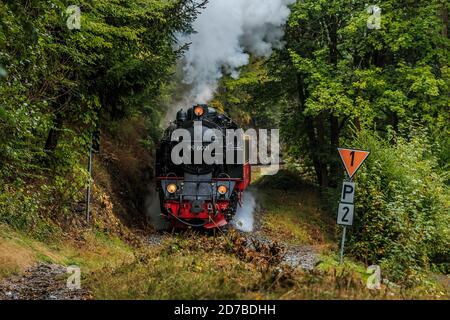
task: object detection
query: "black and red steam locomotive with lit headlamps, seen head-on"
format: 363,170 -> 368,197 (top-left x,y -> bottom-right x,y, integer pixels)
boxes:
155,105 -> 251,229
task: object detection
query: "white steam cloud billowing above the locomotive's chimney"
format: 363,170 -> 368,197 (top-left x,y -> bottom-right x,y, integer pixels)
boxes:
178,0 -> 295,104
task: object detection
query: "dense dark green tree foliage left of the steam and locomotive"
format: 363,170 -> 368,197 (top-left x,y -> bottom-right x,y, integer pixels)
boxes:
0,0 -> 204,235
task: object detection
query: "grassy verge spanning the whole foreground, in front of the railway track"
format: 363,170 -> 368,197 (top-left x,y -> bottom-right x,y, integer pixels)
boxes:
0,218 -> 448,299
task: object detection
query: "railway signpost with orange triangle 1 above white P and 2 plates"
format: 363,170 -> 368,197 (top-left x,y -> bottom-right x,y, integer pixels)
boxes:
337,148 -> 370,264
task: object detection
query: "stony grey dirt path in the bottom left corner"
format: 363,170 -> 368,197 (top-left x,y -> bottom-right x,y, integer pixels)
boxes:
0,263 -> 89,300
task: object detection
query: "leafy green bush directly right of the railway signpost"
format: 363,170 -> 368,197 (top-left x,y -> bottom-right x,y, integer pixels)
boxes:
349,131 -> 450,282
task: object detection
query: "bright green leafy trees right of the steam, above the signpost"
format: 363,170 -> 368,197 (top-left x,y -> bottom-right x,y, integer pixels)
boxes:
279,1 -> 449,186
